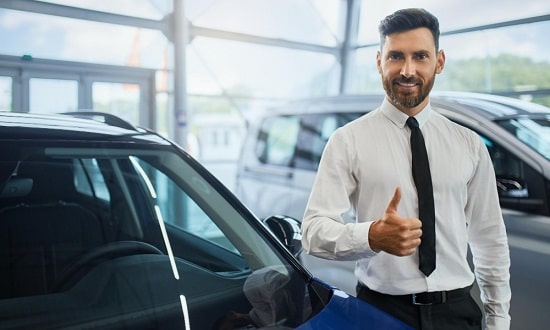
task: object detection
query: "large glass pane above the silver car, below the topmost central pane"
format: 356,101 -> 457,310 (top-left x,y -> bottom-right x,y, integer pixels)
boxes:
187,37 -> 340,98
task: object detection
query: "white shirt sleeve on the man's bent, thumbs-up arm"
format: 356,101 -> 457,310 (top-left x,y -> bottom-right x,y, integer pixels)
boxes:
302,130 -> 374,260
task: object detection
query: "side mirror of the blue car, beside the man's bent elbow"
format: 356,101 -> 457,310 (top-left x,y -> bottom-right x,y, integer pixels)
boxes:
264,215 -> 302,257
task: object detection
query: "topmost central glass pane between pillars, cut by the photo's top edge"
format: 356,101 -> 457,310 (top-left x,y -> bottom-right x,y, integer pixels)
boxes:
190,0 -> 345,46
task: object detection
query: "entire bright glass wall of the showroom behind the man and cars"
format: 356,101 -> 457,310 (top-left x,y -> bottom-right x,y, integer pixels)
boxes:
0,0 -> 550,153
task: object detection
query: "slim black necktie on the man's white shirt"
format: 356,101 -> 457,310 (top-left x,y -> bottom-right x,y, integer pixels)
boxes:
407,117 -> 435,276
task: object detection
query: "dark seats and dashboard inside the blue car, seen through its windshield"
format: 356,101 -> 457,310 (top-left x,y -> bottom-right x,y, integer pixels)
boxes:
0,153 -> 252,328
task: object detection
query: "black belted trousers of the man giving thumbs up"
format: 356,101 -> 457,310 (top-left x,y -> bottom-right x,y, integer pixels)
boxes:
357,284 -> 483,330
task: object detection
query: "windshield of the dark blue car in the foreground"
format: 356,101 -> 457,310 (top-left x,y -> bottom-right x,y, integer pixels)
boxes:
0,141 -> 311,329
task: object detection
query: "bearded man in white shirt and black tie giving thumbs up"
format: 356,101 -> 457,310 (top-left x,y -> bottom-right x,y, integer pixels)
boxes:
302,9 -> 511,330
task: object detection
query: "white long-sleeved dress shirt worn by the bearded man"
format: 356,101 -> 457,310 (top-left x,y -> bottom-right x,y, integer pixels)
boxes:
302,100 -> 511,329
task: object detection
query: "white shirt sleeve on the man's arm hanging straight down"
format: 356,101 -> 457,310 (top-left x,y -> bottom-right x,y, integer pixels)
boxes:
466,136 -> 511,329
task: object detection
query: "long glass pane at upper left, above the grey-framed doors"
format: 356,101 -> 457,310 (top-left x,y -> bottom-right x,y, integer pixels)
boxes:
0,8 -> 168,68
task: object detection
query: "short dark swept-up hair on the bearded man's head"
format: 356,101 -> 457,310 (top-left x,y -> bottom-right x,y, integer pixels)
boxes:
378,8 -> 439,51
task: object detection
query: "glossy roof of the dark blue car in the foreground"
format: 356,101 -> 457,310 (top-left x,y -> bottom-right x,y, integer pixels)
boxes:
0,111 -> 168,142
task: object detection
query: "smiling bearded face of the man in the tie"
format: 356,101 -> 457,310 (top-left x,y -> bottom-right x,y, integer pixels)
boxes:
376,28 -> 445,116
